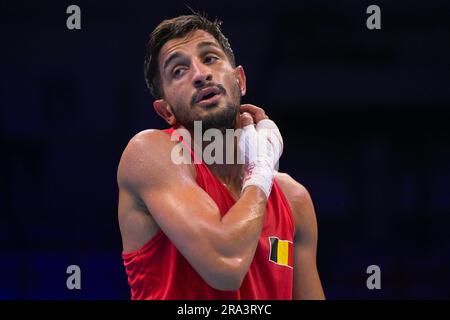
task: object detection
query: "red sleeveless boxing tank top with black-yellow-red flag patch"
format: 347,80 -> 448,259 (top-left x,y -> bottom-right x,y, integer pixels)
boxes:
122,128 -> 294,300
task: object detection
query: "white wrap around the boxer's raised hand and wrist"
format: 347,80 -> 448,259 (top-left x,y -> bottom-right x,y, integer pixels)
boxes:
239,119 -> 283,198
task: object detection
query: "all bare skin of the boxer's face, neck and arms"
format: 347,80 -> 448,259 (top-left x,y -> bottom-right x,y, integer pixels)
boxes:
117,30 -> 324,299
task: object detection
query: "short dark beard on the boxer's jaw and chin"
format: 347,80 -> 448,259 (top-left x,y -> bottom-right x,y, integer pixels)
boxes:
173,83 -> 241,134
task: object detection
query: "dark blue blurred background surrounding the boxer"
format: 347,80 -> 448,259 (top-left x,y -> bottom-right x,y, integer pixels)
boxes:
0,0 -> 450,299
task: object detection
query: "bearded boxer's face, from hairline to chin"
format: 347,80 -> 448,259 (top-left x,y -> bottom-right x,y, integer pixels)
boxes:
159,30 -> 241,130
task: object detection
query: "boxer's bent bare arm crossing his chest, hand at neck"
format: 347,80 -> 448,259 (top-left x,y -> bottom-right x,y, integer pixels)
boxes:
118,130 -> 267,290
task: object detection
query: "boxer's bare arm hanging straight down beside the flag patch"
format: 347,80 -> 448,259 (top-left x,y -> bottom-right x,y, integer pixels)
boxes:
276,173 -> 325,300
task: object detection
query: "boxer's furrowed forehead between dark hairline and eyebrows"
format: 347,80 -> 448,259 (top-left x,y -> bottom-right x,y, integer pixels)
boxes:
159,30 -> 220,63
